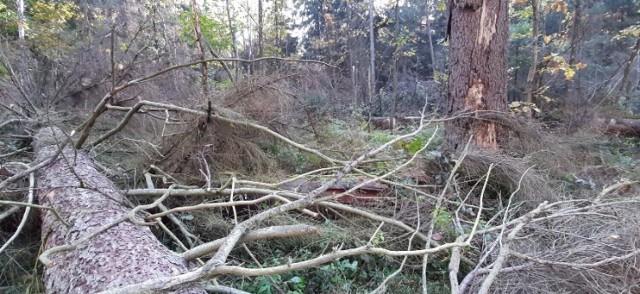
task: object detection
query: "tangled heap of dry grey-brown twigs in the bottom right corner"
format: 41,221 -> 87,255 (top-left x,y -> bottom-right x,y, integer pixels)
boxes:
462,199 -> 640,294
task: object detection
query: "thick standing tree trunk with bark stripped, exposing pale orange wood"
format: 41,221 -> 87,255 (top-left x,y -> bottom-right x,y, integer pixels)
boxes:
444,0 -> 509,153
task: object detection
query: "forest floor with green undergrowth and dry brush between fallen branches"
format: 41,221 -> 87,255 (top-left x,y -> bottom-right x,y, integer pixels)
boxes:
0,107 -> 640,293
